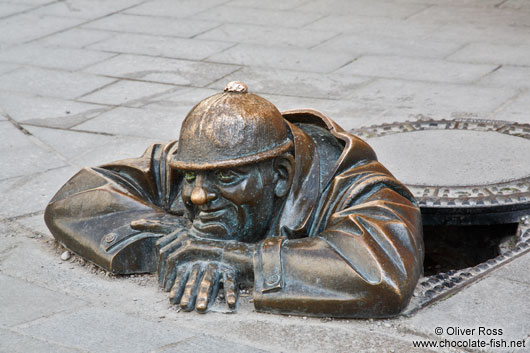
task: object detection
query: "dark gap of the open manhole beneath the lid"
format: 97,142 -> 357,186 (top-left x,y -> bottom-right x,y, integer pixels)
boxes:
423,223 -> 518,276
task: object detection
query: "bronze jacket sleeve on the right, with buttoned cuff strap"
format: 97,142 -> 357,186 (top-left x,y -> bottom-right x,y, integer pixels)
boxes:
254,162 -> 424,318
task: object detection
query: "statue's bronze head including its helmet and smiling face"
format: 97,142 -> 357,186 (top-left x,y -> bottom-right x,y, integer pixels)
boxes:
170,82 -> 294,242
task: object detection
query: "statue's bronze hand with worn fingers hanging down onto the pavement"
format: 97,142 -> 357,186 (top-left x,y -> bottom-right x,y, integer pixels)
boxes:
157,230 -> 255,312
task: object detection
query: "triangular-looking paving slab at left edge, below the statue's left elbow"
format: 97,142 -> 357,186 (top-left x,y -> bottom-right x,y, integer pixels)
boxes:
0,274 -> 86,326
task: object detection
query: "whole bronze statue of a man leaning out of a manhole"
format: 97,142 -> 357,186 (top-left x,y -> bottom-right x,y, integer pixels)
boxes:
45,82 -> 423,318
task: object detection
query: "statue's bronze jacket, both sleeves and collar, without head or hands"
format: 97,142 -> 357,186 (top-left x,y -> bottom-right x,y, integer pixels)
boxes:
45,110 -> 423,317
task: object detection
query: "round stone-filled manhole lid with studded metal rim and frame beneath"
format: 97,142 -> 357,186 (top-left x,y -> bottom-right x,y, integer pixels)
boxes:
352,120 -> 530,315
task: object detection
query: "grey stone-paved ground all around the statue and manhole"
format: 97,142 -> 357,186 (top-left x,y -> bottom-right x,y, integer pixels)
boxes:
0,0 -> 530,352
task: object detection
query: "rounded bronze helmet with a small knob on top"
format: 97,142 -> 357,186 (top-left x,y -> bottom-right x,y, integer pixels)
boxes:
169,82 -> 293,170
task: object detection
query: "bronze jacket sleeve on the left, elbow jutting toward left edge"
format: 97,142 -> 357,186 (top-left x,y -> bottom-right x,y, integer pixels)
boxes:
44,143 -> 187,274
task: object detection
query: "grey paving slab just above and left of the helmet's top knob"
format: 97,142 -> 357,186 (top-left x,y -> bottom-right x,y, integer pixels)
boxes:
84,54 -> 239,87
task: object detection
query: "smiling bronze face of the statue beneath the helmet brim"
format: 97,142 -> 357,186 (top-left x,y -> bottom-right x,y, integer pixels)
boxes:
178,161 -> 275,242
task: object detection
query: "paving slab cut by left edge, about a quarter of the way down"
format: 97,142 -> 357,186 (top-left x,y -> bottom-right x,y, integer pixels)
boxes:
0,67 -> 115,99
